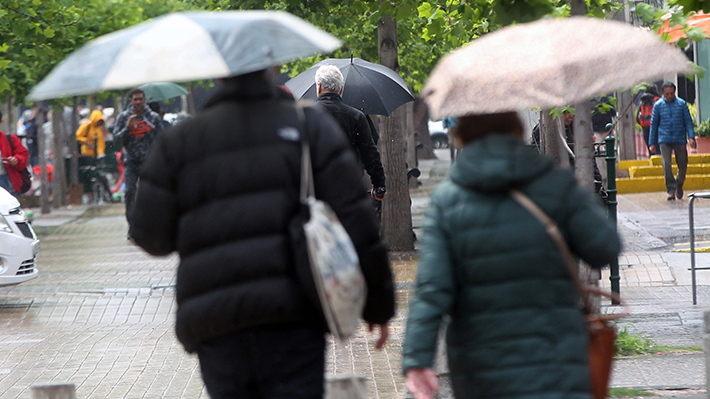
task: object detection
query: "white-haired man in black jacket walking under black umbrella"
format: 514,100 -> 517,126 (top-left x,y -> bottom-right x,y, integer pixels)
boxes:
316,65 -> 385,200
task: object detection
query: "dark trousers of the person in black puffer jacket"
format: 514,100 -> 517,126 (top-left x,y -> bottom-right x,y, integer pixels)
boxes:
197,325 -> 325,399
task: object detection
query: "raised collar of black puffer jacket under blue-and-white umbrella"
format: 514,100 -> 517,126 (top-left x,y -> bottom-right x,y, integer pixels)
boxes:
204,72 -> 278,109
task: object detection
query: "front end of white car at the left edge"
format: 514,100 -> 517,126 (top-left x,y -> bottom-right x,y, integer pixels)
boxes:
0,188 -> 39,286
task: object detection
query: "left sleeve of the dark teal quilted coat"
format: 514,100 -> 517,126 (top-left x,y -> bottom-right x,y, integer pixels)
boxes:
402,194 -> 456,374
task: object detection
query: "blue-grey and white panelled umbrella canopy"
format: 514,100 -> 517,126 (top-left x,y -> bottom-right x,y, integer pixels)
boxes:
29,11 -> 340,100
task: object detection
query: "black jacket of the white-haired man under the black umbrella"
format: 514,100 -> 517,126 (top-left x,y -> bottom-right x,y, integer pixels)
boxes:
316,93 -> 385,187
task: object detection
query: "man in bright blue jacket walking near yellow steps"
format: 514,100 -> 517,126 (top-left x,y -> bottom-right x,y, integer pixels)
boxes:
648,82 -> 695,201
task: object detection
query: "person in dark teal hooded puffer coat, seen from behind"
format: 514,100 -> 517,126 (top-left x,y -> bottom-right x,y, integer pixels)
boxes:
402,112 -> 621,399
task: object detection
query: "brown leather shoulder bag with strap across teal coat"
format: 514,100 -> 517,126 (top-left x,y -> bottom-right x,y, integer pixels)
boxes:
510,190 -> 628,399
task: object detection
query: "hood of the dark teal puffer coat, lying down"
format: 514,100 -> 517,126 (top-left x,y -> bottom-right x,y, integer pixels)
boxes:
451,133 -> 554,192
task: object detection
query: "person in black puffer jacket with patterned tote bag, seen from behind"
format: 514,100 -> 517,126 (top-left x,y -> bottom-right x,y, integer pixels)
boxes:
130,71 -> 394,398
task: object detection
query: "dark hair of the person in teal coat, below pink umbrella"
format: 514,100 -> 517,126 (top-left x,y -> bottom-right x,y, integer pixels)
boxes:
454,112 -> 523,144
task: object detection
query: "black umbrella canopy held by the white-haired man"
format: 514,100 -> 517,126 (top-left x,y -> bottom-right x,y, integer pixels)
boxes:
286,58 -> 414,116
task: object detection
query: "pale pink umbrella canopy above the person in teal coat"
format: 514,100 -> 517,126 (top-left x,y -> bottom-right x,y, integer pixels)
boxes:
422,17 -> 690,120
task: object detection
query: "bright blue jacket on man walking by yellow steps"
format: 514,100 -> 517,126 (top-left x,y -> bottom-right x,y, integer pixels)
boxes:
648,97 -> 695,145
